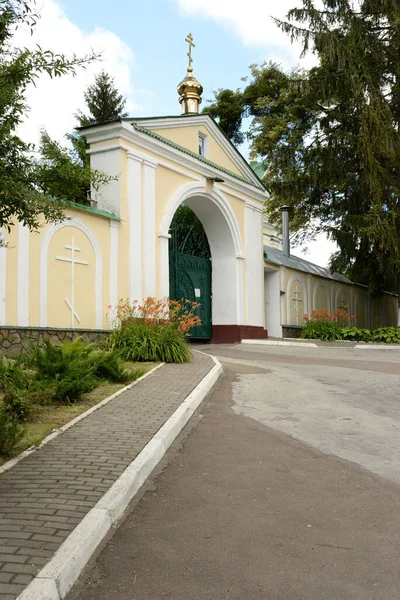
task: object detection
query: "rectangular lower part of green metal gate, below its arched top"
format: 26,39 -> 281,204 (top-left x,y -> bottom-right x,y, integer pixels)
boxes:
169,252 -> 211,340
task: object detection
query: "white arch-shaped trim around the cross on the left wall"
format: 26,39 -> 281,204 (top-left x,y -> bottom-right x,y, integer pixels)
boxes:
40,217 -> 103,329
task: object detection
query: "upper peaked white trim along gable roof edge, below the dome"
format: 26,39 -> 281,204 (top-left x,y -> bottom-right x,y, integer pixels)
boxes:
125,114 -> 260,185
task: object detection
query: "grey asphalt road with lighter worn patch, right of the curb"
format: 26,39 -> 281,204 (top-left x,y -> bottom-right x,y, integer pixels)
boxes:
70,346 -> 400,600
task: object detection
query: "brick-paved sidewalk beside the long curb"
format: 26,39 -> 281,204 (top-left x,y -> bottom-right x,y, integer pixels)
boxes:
0,352 -> 214,600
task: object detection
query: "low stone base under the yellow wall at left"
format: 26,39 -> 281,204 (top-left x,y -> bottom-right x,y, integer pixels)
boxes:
0,326 -> 111,356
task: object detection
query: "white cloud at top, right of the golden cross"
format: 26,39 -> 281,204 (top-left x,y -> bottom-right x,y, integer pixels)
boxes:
176,0 -> 315,67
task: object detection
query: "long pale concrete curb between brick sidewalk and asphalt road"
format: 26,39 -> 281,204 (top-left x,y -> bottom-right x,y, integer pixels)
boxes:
17,356 -> 222,600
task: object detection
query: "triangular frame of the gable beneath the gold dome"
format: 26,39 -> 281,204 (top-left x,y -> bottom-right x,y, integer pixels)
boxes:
128,113 -> 265,190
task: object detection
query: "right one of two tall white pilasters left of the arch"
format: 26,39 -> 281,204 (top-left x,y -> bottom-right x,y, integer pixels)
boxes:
142,160 -> 157,298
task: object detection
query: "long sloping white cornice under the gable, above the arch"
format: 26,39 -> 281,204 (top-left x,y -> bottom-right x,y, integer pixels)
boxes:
85,123 -> 268,202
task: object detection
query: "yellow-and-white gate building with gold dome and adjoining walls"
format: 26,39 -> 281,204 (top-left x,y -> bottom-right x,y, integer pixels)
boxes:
0,45 -> 397,343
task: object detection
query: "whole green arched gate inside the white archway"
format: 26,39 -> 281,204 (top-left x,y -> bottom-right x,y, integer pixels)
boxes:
169,204 -> 211,340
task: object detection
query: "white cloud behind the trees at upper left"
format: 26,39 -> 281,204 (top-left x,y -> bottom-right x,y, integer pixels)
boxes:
14,0 -> 138,149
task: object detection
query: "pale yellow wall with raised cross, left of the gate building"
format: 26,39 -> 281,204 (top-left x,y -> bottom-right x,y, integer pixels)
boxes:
5,209 -> 110,329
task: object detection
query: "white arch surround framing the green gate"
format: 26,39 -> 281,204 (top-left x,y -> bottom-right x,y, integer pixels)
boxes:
159,182 -> 245,342
